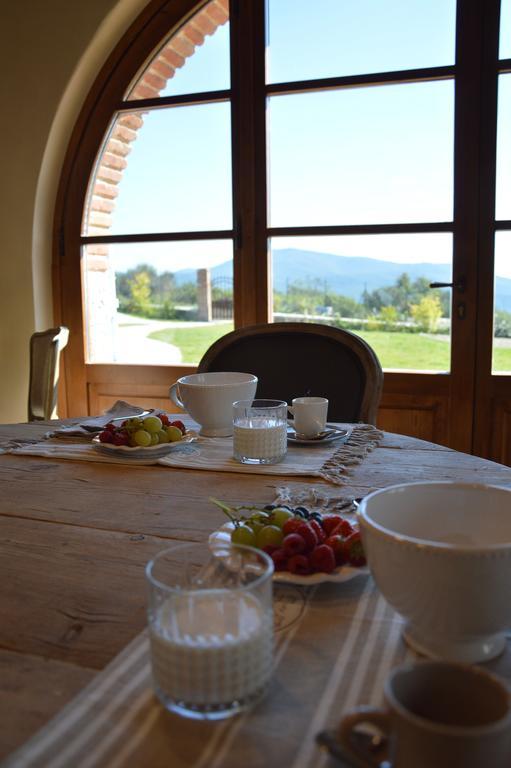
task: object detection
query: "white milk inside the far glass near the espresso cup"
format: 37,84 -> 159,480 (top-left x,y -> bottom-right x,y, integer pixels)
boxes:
233,416 -> 287,464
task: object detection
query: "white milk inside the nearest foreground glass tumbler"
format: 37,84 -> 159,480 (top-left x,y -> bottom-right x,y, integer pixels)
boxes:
150,589 -> 273,711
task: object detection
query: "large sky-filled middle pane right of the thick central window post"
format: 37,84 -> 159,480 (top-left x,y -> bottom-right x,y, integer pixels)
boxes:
269,81 -> 454,227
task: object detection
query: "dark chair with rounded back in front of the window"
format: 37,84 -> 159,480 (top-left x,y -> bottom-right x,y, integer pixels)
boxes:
197,323 -> 383,424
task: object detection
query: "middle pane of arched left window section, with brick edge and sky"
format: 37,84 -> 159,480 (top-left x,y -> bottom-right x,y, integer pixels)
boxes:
85,102 -> 232,235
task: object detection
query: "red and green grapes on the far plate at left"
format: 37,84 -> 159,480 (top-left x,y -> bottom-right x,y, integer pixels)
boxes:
99,413 -> 186,448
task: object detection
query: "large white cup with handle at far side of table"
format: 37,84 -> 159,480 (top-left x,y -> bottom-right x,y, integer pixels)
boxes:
169,371 -> 257,437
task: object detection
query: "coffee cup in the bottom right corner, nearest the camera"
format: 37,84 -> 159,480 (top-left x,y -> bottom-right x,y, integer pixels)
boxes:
339,661 -> 511,768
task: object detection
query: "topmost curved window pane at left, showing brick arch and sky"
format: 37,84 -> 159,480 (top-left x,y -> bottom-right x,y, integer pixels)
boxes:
126,0 -> 230,100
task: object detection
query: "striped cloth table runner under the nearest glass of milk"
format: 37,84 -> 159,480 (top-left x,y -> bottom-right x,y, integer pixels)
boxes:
5,574 -> 418,768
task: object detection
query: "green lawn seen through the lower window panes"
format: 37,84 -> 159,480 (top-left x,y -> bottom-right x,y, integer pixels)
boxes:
149,323 -> 511,371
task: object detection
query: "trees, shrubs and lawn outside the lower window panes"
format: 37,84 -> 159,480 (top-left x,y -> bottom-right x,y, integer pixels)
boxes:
116,252 -> 511,371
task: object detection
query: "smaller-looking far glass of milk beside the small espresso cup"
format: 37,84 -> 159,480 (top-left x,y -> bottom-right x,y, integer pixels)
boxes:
232,400 -> 287,464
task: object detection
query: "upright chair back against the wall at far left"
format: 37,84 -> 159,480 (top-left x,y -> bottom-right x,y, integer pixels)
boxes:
28,326 -> 69,421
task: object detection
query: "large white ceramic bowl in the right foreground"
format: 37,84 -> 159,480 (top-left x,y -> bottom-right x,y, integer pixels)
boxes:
358,482 -> 511,663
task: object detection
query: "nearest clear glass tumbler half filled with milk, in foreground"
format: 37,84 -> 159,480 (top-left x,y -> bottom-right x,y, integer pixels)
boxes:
146,542 -> 273,720
